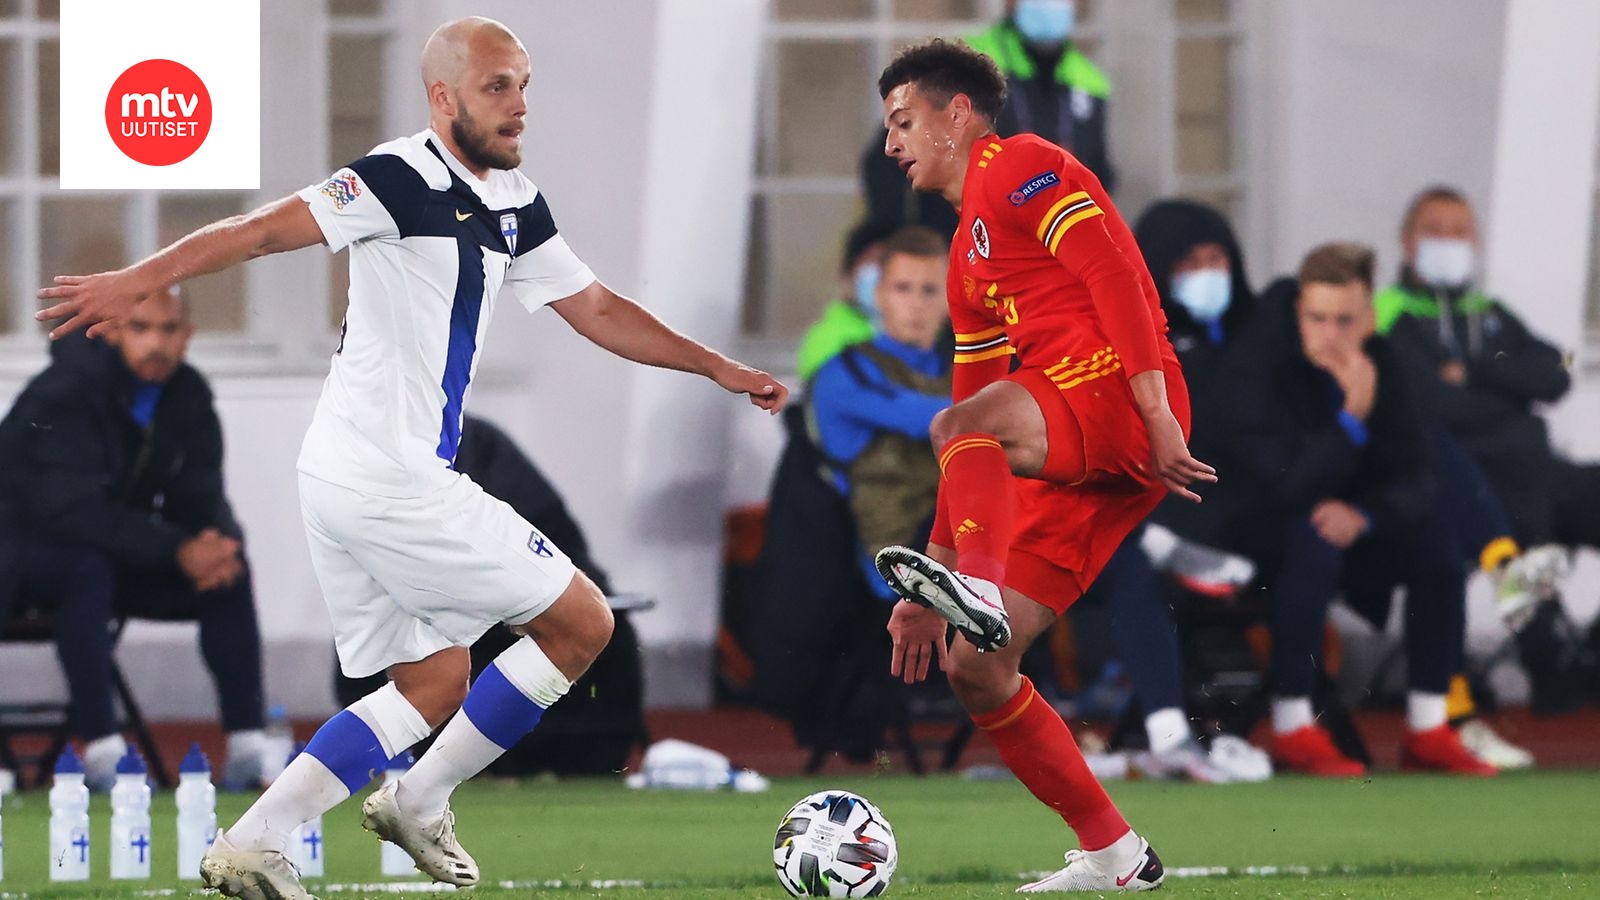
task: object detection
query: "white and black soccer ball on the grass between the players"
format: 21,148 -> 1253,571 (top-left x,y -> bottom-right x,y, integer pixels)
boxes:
773,791 -> 899,897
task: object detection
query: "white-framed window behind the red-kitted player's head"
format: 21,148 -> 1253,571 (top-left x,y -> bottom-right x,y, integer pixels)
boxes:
742,0 -> 1259,344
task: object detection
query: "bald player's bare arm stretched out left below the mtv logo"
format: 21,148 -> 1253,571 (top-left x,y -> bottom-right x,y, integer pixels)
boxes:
35,197 -> 322,340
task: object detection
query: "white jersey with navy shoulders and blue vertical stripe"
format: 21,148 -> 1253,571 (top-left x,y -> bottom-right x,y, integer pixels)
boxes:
299,131 -> 595,496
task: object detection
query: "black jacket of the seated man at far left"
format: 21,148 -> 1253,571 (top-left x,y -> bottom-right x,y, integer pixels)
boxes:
0,338 -> 242,586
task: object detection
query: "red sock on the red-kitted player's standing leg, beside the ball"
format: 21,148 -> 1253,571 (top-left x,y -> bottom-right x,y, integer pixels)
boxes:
973,676 -> 1128,850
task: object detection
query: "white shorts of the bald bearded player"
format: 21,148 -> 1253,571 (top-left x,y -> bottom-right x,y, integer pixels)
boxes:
299,472 -> 578,677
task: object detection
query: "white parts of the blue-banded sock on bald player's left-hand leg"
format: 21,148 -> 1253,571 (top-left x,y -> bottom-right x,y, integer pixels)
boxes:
227,682 -> 432,854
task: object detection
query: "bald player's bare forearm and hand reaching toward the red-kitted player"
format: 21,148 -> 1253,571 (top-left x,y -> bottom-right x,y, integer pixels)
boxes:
550,280 -> 789,413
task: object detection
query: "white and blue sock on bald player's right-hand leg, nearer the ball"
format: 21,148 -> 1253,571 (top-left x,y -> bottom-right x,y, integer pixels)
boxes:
395,637 -> 573,822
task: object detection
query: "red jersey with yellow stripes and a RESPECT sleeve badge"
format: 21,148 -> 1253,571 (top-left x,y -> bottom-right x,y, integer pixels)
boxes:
947,135 -> 1178,400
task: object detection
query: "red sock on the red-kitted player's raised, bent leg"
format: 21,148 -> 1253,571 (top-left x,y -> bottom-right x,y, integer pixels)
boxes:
939,432 -> 1016,585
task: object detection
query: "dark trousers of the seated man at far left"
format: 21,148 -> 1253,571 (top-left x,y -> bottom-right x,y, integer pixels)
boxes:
18,541 -> 262,740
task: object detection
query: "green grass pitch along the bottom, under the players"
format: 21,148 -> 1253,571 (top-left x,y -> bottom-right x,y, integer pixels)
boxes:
0,772 -> 1600,900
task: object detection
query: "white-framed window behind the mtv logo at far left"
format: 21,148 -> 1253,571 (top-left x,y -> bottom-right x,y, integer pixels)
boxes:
0,0 -> 397,356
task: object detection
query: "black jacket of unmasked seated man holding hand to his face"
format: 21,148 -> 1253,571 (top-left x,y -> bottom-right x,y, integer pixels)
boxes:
1208,279 -> 1434,546
